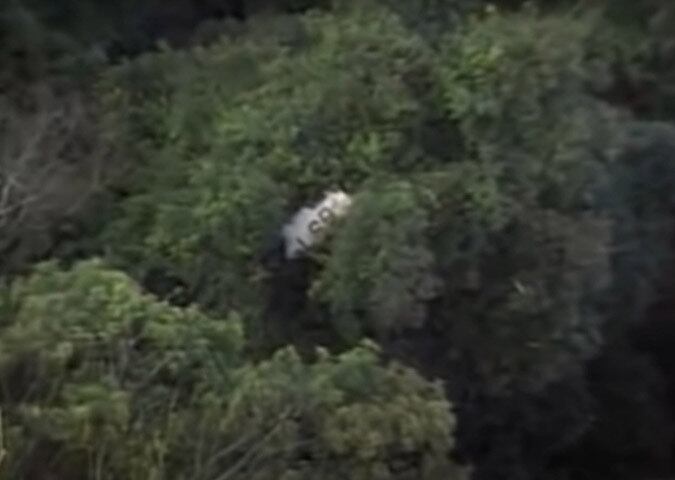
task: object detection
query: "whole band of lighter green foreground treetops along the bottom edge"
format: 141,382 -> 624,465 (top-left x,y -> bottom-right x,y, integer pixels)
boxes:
0,260 -> 460,480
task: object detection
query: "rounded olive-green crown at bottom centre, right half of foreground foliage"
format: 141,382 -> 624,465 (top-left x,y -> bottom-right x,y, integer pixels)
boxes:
222,345 -> 462,479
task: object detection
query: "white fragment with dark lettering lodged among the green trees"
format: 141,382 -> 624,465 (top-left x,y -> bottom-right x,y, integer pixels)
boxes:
282,190 -> 352,259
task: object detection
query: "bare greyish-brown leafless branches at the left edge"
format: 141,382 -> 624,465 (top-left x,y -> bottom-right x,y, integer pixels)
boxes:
0,88 -> 113,269
